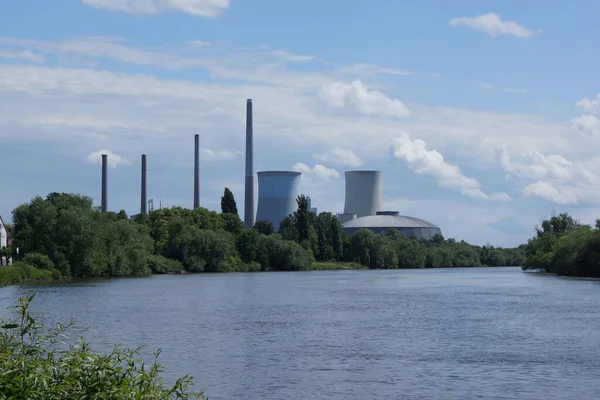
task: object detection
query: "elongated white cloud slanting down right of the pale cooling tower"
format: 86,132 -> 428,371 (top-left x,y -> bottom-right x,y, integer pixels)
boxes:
390,132 -> 510,201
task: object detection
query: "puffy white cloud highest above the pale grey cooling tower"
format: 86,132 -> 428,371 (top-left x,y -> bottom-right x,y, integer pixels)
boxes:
318,81 -> 410,118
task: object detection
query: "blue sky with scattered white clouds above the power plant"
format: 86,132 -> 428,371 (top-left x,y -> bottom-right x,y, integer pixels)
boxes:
0,0 -> 600,247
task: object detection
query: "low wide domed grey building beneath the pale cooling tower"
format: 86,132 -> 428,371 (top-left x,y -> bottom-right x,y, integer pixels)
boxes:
342,211 -> 442,239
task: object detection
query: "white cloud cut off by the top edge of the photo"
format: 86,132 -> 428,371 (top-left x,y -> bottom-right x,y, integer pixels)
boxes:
82,0 -> 229,18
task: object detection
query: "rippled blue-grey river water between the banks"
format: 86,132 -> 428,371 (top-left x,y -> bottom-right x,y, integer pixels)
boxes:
0,268 -> 600,400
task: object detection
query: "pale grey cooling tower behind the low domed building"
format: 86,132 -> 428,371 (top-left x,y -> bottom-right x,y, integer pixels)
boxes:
344,171 -> 383,218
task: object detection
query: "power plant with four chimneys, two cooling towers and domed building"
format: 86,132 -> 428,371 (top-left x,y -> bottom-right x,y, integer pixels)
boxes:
95,99 -> 442,239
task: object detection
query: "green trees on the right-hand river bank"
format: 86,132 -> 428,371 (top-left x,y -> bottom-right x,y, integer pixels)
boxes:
522,213 -> 600,278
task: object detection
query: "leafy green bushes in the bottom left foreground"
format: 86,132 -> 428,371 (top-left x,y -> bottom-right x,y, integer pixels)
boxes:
0,296 -> 204,400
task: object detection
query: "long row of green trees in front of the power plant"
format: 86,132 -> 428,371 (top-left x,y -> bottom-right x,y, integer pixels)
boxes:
0,189 -> 524,279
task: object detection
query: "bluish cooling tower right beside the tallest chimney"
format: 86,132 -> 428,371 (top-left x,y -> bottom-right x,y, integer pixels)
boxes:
256,171 -> 302,231
